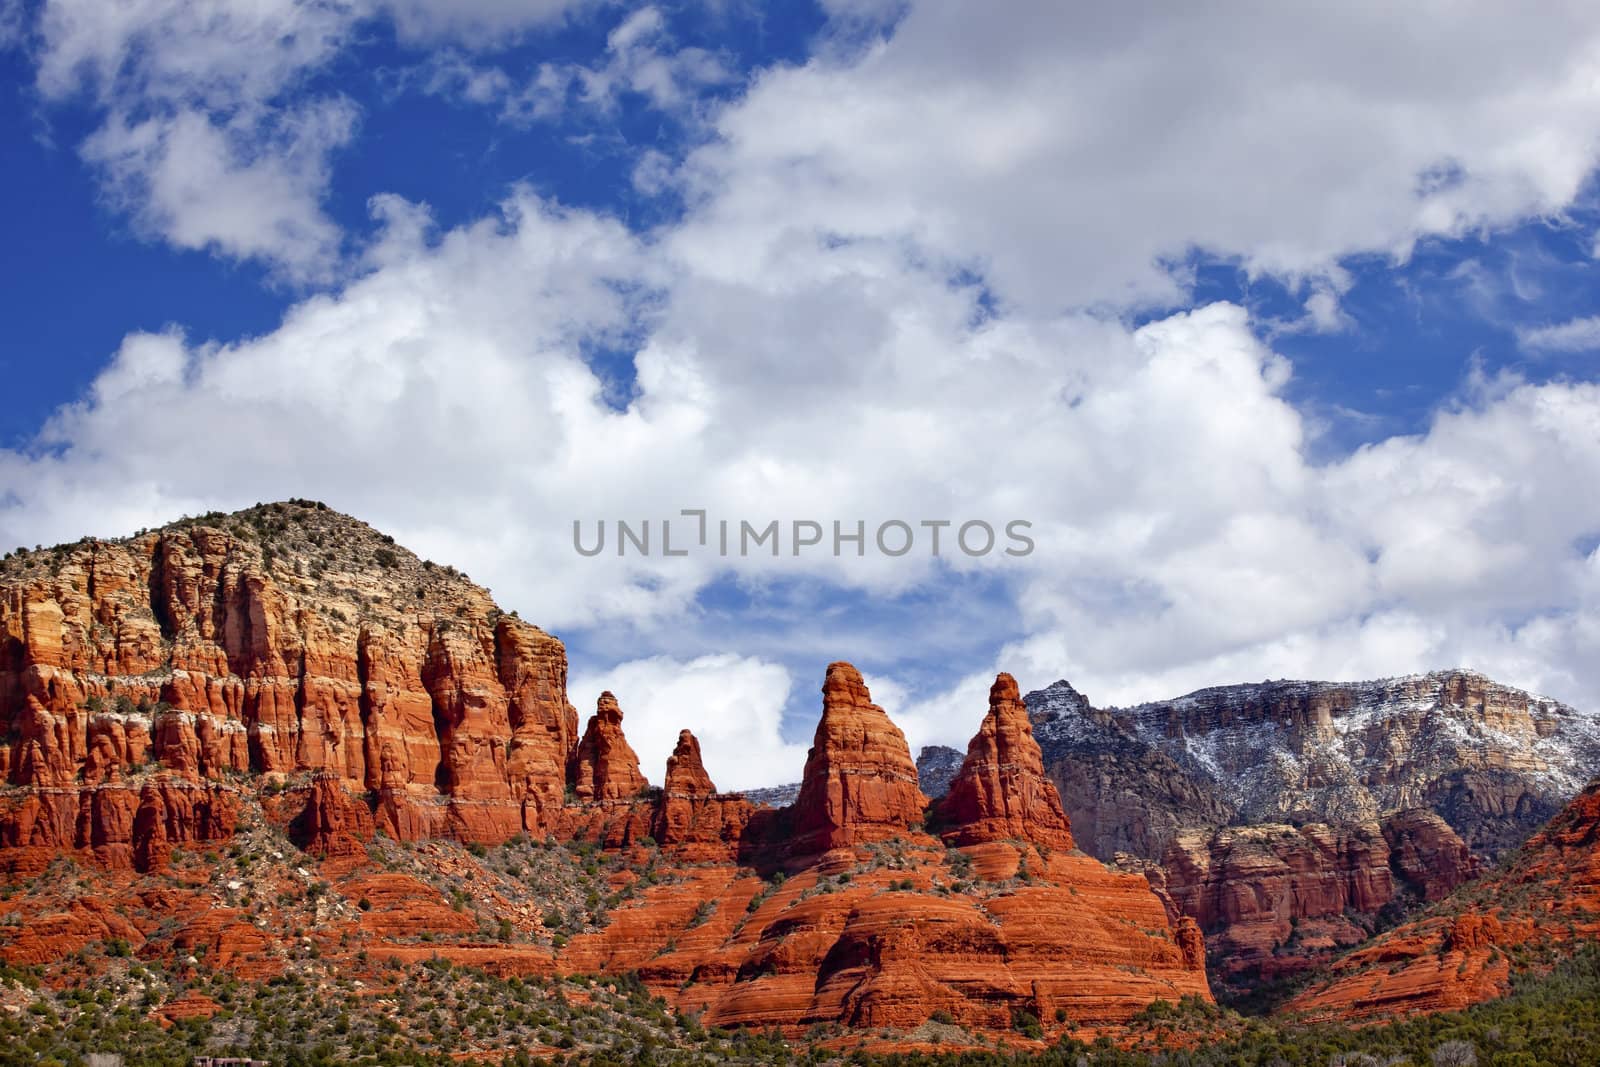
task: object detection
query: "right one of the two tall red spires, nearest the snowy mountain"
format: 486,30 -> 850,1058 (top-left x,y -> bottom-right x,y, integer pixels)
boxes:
939,673 -> 1072,849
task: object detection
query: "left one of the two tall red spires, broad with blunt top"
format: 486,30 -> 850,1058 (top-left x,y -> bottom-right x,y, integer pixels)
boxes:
789,662 -> 928,856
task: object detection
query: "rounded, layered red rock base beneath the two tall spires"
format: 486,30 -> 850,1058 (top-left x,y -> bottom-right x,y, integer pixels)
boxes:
558,835 -> 1210,1033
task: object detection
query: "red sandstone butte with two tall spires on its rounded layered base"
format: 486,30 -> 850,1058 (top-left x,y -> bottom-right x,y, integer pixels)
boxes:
537,664 -> 1210,1033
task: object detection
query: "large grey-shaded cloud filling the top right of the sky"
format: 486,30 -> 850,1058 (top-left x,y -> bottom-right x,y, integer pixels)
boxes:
691,3 -> 1600,310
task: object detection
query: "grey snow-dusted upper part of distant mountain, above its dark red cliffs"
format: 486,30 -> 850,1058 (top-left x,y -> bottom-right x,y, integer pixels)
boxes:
1024,670 -> 1600,859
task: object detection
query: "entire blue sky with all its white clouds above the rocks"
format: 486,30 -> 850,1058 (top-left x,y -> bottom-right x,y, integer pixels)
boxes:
0,0 -> 1600,785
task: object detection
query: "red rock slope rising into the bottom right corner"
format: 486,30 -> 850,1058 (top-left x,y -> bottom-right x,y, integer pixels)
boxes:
1290,781 -> 1600,1019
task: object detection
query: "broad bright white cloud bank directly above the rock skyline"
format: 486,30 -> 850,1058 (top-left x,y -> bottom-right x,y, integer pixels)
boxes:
12,185 -> 1600,751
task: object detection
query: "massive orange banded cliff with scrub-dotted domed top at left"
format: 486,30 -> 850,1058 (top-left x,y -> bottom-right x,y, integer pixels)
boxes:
0,504 -> 576,851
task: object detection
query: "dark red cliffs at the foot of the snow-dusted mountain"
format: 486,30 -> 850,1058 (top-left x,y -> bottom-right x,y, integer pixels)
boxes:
1160,813 -> 1477,987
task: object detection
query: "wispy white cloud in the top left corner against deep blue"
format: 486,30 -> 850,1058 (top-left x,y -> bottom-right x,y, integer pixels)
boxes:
37,0 -> 357,282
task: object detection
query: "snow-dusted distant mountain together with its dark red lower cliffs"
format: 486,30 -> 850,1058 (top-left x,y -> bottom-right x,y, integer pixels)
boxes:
1026,670 -> 1600,993
